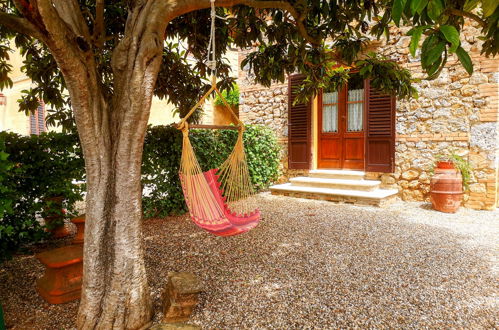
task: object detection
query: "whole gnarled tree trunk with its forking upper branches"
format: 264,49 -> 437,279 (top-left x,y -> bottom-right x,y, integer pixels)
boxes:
0,0 -> 256,329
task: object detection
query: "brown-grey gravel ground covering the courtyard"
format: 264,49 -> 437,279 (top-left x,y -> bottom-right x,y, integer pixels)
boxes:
0,193 -> 499,329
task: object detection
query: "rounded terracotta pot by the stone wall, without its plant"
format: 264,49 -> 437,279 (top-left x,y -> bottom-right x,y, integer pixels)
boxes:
430,167 -> 463,213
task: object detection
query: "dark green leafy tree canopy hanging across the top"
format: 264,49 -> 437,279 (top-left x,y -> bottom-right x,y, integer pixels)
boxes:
0,0 -> 499,130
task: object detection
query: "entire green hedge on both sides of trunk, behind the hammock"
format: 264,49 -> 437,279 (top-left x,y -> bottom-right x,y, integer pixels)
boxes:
0,126 -> 279,261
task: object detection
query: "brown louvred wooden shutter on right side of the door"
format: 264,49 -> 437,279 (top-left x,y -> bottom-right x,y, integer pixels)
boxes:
366,82 -> 395,173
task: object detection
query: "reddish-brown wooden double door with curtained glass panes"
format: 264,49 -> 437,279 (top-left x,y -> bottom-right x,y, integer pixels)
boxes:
317,75 -> 366,170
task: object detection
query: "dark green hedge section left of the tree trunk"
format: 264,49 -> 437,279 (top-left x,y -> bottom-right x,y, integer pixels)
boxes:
0,132 -> 84,261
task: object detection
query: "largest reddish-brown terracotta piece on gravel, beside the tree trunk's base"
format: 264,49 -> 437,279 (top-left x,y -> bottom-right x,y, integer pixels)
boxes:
36,244 -> 83,304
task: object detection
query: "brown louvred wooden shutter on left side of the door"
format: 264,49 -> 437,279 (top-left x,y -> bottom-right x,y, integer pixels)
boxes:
288,75 -> 312,169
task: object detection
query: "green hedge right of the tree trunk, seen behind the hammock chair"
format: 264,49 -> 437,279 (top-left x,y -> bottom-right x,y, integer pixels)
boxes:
142,126 -> 280,217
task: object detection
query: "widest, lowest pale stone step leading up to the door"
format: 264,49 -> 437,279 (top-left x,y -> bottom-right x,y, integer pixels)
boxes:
270,183 -> 398,206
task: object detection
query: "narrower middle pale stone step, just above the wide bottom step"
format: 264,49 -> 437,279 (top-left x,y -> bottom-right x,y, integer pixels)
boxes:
289,176 -> 381,191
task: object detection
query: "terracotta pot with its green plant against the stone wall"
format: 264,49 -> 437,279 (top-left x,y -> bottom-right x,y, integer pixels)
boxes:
430,152 -> 472,213
